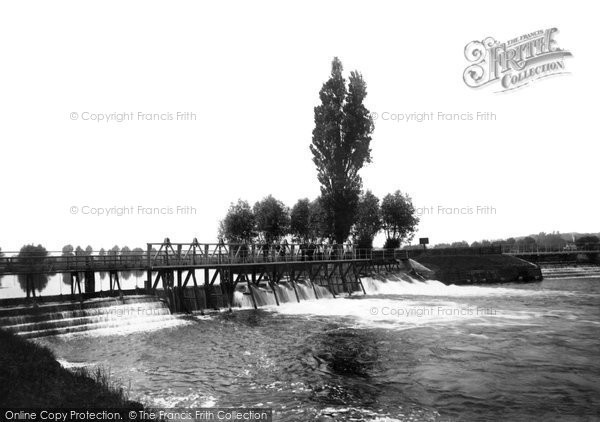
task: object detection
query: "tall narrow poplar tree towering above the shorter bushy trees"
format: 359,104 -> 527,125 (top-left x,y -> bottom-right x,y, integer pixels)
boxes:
310,57 -> 374,243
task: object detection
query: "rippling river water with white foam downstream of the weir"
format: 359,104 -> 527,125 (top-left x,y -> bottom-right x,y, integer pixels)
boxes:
37,278 -> 600,421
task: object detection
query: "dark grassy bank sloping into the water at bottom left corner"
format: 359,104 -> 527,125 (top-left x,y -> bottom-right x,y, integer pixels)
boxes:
0,329 -> 143,409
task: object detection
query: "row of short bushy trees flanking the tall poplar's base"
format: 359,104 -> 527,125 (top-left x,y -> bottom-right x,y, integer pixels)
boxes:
219,190 -> 419,249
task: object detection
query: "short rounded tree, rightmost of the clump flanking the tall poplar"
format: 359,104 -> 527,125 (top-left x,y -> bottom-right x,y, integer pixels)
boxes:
381,190 -> 419,248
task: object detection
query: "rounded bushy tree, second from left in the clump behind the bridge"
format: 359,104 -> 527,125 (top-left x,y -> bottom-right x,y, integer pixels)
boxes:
253,195 -> 290,243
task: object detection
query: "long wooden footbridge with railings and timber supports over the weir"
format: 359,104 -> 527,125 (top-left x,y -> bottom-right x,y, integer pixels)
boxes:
0,239 -> 407,312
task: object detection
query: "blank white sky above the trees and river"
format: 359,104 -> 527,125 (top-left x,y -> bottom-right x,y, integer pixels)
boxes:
0,0 -> 600,251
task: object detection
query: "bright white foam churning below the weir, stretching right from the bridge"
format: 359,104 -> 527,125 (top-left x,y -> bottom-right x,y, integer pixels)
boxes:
230,274 -> 571,330
